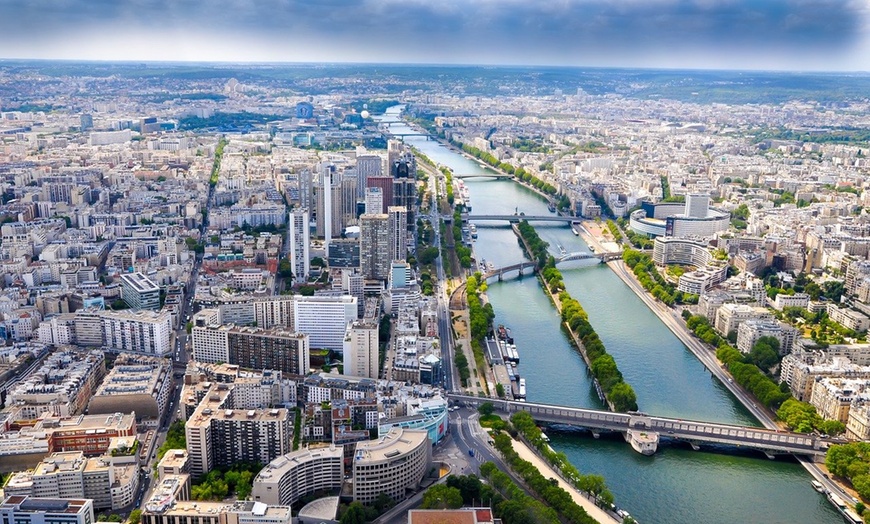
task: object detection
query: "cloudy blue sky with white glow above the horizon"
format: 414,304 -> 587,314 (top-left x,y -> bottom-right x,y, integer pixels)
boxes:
0,0 -> 870,71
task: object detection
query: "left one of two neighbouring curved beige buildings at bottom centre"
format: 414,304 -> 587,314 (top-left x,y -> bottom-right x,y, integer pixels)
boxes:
251,446 -> 344,506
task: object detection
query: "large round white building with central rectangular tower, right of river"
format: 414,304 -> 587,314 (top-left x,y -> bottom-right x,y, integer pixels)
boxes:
629,194 -> 731,237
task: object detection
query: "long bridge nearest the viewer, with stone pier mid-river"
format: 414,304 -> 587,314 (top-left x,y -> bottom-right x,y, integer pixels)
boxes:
449,395 -> 827,460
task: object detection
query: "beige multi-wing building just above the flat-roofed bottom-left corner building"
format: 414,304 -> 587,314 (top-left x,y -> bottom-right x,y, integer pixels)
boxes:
4,451 -> 139,510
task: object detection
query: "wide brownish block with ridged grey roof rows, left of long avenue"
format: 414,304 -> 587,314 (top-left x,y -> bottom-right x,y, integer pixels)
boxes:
88,353 -> 172,426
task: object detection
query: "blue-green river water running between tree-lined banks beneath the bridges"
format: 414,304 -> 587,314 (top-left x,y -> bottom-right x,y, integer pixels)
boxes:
378,108 -> 842,524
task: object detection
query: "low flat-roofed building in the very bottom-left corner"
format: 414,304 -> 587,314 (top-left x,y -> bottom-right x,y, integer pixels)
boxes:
0,495 -> 95,524
